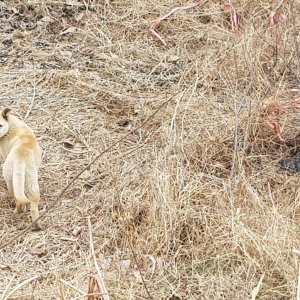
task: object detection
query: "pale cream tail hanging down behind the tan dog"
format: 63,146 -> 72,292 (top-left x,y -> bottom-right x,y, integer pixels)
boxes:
12,161 -> 30,204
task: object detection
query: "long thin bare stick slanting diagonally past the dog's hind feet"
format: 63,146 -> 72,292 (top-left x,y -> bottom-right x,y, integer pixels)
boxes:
0,92 -> 181,250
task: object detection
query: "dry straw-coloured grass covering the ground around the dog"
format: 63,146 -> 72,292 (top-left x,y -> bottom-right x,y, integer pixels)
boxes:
0,0 -> 300,300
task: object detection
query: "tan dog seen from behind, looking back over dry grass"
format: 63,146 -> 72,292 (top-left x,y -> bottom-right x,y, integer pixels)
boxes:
0,108 -> 41,230
